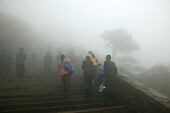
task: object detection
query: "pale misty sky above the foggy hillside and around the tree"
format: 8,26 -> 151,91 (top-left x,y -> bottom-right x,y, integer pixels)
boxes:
0,0 -> 170,66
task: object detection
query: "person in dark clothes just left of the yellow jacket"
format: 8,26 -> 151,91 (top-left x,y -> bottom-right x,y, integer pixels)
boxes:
82,56 -> 93,97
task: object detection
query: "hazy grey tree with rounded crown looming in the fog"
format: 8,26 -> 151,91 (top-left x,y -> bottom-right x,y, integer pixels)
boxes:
102,29 -> 139,58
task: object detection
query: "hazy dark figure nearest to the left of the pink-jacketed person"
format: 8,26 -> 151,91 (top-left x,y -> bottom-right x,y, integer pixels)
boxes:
44,52 -> 53,75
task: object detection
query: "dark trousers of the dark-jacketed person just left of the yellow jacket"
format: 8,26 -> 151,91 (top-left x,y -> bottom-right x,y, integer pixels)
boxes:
84,74 -> 93,96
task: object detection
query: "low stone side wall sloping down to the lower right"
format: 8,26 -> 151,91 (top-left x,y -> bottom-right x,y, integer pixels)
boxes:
115,74 -> 170,113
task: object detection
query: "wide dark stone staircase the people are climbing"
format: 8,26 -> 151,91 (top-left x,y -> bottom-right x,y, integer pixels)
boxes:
0,75 -> 130,113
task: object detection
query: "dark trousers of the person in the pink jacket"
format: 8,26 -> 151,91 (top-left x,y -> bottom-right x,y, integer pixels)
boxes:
61,74 -> 71,96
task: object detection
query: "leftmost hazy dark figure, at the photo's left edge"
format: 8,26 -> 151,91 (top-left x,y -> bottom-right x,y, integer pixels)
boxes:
0,49 -> 12,75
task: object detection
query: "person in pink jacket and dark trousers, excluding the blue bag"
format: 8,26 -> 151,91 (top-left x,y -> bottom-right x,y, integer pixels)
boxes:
58,55 -> 72,96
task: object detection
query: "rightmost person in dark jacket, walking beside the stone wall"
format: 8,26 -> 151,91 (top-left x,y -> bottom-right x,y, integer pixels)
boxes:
104,55 -> 117,99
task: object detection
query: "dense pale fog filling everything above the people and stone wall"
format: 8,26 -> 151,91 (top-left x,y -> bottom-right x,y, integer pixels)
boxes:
0,0 -> 170,96
